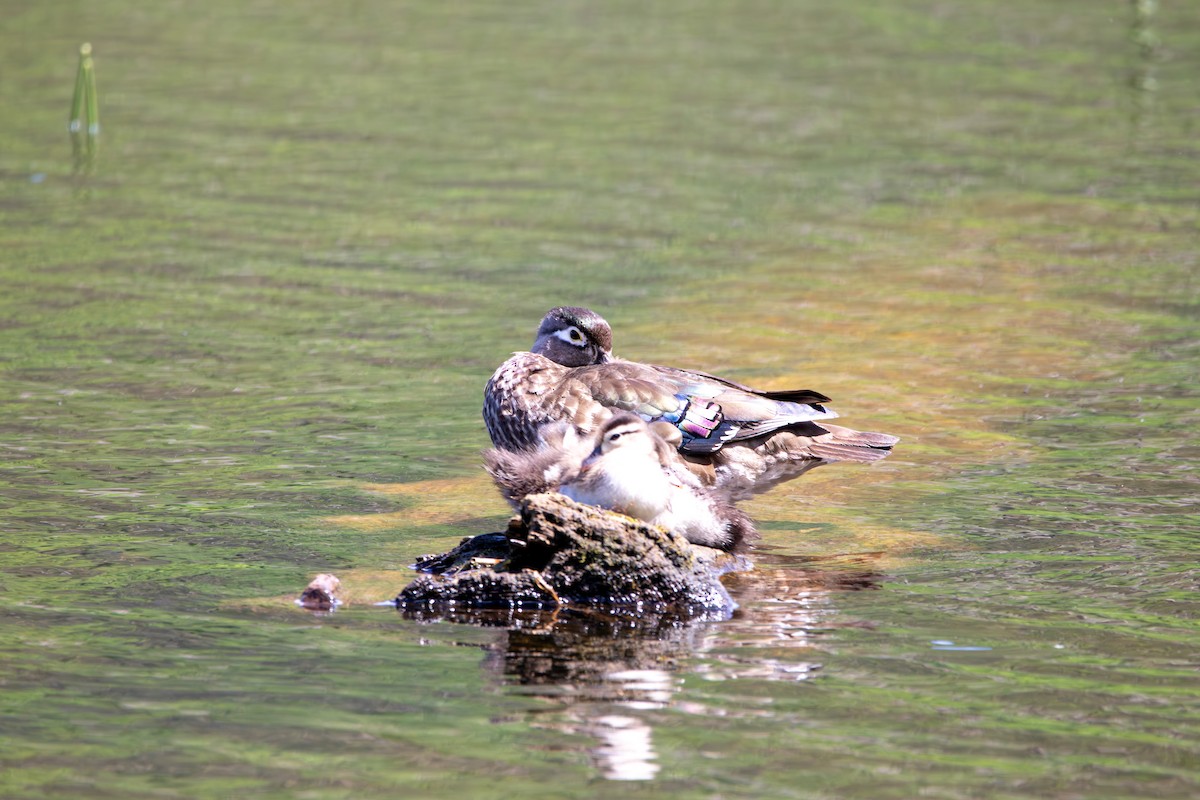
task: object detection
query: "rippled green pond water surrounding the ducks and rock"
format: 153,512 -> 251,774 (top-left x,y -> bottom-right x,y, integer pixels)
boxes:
0,0 -> 1200,800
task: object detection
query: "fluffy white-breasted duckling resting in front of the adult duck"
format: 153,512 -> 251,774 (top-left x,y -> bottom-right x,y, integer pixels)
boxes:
484,411 -> 757,551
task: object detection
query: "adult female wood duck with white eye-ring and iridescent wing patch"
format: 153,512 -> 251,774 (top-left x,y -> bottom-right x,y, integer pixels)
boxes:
484,306 -> 899,497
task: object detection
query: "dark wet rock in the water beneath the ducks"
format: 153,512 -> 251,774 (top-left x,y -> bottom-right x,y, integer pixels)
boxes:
396,493 -> 749,616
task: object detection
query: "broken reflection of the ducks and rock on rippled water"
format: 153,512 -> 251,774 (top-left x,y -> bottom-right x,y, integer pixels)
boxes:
402,553 -> 882,781
